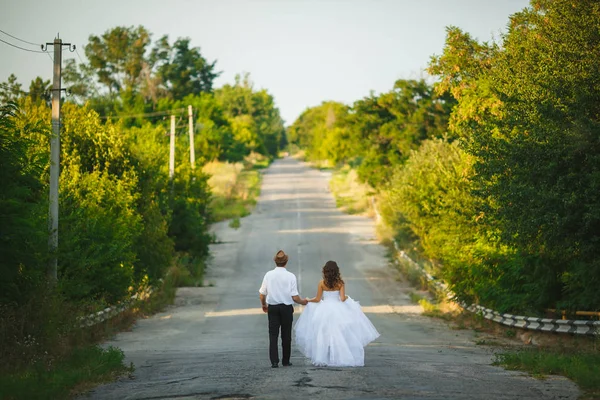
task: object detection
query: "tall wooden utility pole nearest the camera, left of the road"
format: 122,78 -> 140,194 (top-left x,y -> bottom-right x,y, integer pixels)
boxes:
48,38 -> 63,285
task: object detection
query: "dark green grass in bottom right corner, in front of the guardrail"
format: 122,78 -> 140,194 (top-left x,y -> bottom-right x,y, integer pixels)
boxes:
493,348 -> 600,399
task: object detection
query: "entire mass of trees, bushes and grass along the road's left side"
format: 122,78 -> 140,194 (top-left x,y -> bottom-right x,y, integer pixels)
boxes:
0,26 -> 286,399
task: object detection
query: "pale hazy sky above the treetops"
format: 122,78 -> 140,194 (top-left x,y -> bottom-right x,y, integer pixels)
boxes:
0,0 -> 529,125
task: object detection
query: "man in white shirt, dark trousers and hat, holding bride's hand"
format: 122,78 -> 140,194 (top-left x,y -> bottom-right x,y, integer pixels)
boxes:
258,250 -> 308,368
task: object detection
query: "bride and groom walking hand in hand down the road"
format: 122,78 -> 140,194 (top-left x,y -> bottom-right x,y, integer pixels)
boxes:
259,250 -> 379,368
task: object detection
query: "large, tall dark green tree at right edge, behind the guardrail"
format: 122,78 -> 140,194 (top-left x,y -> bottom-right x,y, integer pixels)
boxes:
432,0 -> 600,309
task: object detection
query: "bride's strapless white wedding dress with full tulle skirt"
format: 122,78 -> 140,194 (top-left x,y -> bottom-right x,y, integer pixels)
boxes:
294,290 -> 379,367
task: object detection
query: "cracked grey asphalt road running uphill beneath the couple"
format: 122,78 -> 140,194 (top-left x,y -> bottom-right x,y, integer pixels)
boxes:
82,158 -> 578,400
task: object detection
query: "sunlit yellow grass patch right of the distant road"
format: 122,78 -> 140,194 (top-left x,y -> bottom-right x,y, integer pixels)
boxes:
329,165 -> 375,216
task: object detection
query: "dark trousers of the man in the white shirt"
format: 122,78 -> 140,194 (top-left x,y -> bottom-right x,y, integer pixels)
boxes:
267,304 -> 294,365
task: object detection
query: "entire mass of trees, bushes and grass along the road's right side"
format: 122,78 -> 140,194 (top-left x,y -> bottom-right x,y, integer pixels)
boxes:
288,0 -> 600,393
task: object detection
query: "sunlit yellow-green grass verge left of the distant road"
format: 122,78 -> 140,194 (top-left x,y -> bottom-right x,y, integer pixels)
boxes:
203,155 -> 270,223
